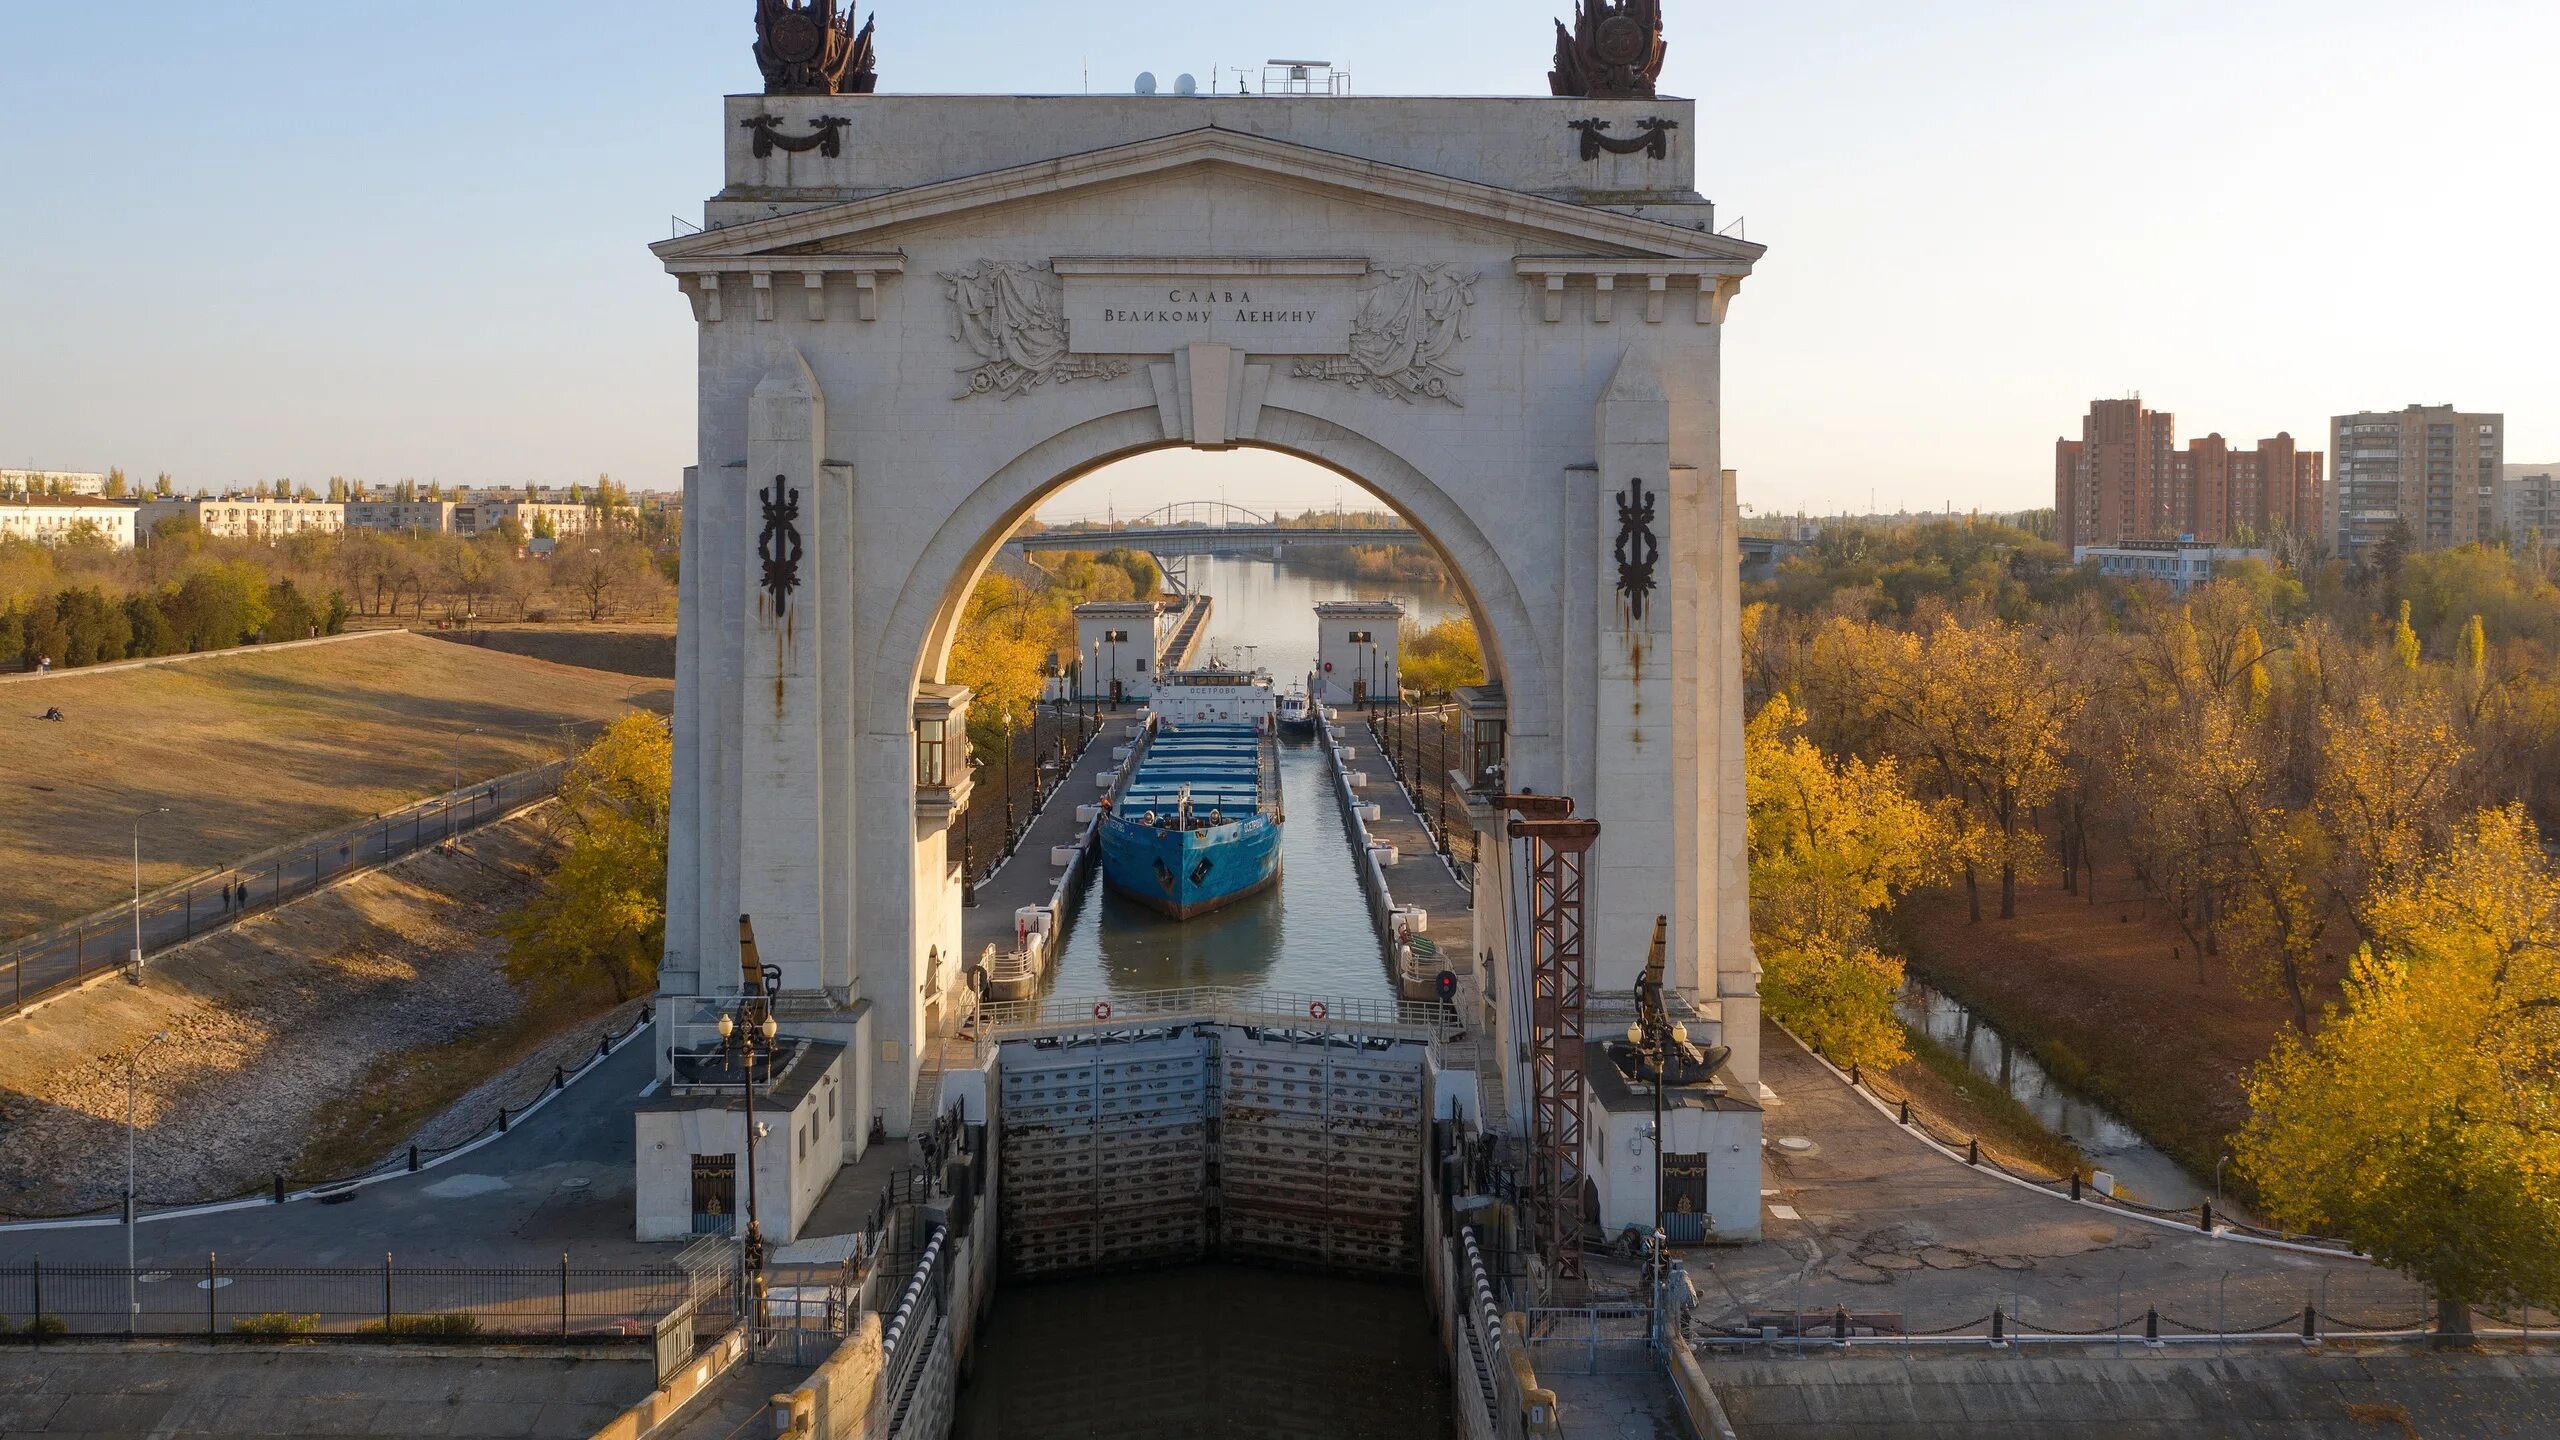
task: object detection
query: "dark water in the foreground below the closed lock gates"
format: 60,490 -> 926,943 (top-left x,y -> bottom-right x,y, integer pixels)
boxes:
952,1266 -> 1449,1440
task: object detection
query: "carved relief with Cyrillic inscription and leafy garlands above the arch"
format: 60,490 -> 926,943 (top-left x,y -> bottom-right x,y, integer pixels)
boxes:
942,259 -> 1477,405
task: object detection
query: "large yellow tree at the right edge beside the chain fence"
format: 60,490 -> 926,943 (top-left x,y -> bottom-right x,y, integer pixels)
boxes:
2235,805 -> 2560,1335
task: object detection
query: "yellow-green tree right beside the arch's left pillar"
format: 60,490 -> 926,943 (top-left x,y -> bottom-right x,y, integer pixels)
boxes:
504,710 -> 676,1002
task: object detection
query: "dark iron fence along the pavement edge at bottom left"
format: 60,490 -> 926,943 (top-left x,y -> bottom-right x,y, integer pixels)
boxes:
0,1256 -> 694,1345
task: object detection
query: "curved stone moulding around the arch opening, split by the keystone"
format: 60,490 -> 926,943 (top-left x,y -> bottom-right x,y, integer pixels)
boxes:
865,405 -> 1549,733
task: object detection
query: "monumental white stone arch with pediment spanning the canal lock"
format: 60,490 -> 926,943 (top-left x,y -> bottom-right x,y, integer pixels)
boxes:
655,67 -> 1761,1222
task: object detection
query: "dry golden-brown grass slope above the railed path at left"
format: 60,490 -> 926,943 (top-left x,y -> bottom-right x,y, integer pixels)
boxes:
0,635 -> 671,940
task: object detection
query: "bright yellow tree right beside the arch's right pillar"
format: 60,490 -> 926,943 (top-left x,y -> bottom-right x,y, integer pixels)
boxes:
1743,694 -> 1951,1066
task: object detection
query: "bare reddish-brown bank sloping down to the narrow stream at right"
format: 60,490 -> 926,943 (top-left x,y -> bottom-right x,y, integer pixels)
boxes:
1894,874 -> 2324,1176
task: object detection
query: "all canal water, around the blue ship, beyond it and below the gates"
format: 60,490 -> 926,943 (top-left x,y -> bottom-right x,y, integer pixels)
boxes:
972,559 -> 1464,1440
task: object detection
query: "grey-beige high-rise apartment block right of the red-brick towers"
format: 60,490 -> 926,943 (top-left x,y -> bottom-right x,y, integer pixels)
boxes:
2330,405 -> 2506,561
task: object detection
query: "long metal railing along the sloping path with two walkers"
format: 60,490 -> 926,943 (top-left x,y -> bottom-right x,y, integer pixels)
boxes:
0,761 -> 566,1017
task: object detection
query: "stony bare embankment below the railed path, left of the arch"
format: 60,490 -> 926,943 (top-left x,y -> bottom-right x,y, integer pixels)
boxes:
0,810 -> 594,1215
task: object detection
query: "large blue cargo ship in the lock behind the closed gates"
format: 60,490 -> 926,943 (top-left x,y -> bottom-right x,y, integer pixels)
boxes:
1101,666 -> 1283,920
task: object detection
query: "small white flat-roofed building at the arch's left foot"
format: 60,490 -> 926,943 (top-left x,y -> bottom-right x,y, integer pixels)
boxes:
632,1035 -> 868,1245
